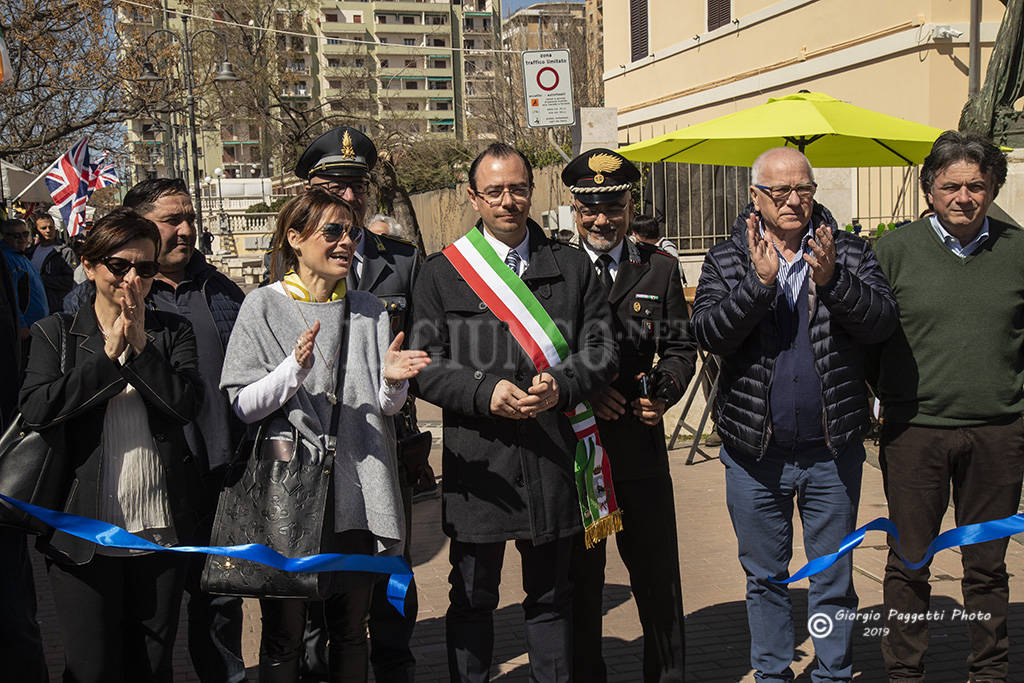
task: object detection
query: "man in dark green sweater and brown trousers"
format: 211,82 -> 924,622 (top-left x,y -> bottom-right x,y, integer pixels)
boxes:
876,131 -> 1024,681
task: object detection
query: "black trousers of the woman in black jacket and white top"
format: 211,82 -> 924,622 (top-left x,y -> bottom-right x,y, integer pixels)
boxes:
46,553 -> 184,683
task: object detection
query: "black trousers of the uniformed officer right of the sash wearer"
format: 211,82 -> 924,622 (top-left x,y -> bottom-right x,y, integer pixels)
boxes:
570,472 -> 686,683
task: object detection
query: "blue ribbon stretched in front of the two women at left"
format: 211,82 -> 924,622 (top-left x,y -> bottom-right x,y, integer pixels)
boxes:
0,494 -> 413,616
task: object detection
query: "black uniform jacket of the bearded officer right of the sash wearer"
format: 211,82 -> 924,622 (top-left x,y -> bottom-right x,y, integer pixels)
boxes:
597,240 -> 696,481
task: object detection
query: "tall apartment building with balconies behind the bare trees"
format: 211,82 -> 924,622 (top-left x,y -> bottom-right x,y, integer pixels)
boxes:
121,0 -> 501,187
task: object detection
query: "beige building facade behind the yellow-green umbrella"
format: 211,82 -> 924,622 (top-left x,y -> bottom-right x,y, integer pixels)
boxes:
603,0 -> 1005,257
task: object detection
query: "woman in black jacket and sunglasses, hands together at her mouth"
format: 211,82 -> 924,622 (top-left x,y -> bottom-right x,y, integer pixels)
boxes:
22,209 -> 202,683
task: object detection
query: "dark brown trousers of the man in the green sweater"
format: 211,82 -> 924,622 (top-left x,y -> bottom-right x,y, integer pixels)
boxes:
879,419 -> 1024,681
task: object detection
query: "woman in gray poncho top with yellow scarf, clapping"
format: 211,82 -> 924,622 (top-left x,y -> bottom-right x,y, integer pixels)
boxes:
221,189 -> 430,683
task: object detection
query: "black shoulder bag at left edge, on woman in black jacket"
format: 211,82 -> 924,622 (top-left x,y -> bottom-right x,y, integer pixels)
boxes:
0,313 -> 74,533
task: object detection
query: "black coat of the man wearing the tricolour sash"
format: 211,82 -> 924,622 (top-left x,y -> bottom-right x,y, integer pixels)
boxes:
410,221 -> 618,543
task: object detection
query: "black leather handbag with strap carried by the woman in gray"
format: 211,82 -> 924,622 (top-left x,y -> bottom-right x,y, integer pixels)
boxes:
201,305 -> 348,600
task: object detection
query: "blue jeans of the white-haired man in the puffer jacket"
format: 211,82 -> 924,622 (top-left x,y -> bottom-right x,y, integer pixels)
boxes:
721,442 -> 864,683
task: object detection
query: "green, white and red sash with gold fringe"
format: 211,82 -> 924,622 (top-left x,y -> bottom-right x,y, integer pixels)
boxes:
441,229 -> 623,548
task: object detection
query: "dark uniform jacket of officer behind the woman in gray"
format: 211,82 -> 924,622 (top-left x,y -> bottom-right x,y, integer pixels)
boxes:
358,230 -> 420,335
